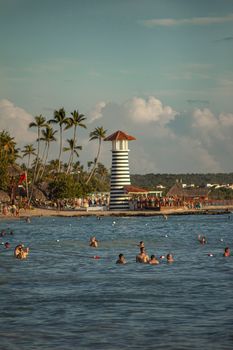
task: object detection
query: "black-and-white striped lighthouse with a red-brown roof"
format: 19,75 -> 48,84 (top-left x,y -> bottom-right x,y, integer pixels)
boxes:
104,130 -> 136,210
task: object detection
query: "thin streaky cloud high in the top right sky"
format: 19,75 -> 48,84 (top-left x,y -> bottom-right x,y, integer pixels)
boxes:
141,13 -> 233,27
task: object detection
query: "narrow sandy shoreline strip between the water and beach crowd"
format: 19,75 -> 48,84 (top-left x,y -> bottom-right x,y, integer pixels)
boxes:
0,206 -> 233,221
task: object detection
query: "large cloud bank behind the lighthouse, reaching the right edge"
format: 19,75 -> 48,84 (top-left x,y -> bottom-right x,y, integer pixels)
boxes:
87,96 -> 233,174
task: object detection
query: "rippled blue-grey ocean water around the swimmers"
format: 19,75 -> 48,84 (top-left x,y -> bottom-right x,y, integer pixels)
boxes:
0,214 -> 233,350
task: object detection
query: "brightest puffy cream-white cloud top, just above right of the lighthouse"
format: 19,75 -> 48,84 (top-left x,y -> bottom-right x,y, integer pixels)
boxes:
124,96 -> 178,125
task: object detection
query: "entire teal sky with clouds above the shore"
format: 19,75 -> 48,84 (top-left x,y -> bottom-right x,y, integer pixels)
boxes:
0,0 -> 233,174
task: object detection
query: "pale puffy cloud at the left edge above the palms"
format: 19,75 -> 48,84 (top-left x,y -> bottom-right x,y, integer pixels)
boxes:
0,99 -> 37,144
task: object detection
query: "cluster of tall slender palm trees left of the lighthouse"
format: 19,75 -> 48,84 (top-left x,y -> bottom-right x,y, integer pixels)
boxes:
22,108 -> 106,184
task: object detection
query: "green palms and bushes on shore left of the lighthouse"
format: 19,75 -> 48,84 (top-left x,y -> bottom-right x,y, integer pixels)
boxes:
0,108 -> 109,199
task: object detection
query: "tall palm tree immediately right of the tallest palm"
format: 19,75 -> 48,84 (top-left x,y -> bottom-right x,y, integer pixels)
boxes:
65,110 -> 87,173
